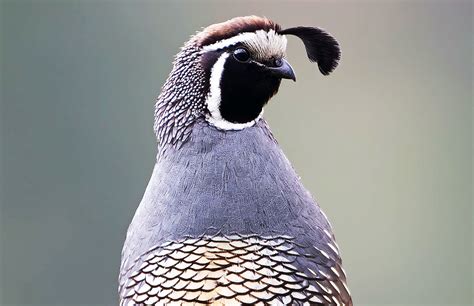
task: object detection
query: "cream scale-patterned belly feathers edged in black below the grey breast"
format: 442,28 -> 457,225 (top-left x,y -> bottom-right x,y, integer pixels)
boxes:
122,232 -> 349,305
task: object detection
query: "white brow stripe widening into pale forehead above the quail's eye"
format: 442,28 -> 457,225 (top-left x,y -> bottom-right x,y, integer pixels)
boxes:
203,30 -> 287,57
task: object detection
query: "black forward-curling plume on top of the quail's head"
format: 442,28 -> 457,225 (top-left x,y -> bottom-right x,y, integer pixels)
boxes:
278,27 -> 341,75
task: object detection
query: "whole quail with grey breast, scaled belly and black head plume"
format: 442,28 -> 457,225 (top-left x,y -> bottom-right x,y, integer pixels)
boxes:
119,16 -> 352,305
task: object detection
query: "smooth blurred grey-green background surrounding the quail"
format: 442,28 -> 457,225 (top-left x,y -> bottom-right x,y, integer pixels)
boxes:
0,0 -> 473,305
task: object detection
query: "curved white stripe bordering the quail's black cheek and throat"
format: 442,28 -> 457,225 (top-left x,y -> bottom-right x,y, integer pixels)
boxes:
206,53 -> 263,130
